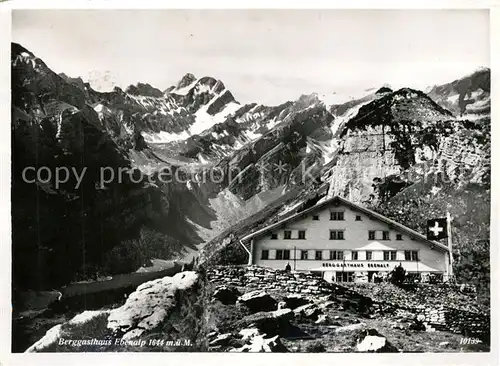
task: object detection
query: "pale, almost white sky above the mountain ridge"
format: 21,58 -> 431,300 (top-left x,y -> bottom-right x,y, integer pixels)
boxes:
12,9 -> 490,105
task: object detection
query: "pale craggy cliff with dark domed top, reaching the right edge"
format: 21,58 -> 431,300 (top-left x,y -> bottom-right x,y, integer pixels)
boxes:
330,84 -> 490,207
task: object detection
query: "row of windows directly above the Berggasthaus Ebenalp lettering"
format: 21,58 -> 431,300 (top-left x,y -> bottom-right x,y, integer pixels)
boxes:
261,249 -> 418,261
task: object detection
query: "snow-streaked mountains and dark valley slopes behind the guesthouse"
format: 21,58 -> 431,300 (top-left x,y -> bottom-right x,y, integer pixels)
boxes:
11,43 -> 491,318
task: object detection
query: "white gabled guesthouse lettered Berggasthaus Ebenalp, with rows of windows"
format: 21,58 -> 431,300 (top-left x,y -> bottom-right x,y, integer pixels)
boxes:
241,197 -> 452,282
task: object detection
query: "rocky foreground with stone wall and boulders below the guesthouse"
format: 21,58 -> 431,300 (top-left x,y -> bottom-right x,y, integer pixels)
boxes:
23,266 -> 489,352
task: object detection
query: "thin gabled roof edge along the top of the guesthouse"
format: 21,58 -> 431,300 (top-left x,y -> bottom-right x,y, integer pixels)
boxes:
241,196 -> 449,252
